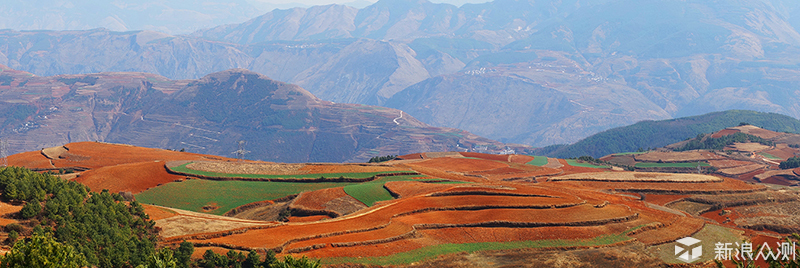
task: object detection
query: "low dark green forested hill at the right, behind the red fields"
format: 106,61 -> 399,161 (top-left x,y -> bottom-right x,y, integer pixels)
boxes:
536,110 -> 800,158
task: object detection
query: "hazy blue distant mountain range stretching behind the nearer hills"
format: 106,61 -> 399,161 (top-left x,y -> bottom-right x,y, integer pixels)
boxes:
0,0 -> 800,146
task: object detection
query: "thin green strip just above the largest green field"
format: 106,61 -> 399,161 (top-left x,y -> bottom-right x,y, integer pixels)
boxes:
170,163 -> 414,179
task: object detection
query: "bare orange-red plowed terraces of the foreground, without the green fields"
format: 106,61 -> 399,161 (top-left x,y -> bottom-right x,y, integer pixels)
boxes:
12,142 -> 800,266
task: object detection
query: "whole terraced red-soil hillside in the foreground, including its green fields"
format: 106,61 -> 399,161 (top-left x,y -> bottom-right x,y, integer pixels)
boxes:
6,143 -> 800,268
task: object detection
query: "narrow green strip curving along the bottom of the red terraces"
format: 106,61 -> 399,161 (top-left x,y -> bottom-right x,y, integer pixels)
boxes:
322,232 -> 631,265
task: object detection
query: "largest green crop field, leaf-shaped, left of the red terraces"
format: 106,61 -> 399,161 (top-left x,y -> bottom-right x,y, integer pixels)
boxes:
136,175 -> 429,215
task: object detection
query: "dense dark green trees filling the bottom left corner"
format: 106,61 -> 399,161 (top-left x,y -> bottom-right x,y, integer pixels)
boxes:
0,167 -> 319,268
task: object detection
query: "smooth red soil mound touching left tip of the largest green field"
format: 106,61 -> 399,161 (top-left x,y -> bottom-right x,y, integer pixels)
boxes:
75,161 -> 186,194
